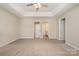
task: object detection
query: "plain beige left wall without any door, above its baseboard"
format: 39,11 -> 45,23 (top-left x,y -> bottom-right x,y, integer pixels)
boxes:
0,8 -> 19,47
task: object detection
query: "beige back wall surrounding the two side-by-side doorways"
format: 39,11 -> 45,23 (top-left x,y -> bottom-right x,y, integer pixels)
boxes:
20,17 -> 57,39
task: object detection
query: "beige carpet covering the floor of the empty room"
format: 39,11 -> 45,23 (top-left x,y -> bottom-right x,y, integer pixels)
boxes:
0,39 -> 79,56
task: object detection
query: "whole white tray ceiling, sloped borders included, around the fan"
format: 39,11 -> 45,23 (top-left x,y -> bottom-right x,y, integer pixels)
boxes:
0,3 -> 77,17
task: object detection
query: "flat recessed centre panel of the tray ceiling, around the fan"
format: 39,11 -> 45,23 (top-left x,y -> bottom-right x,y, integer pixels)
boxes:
18,3 -> 58,12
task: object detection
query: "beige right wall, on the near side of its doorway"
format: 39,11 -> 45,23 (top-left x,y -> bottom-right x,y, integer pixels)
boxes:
59,5 -> 79,49
